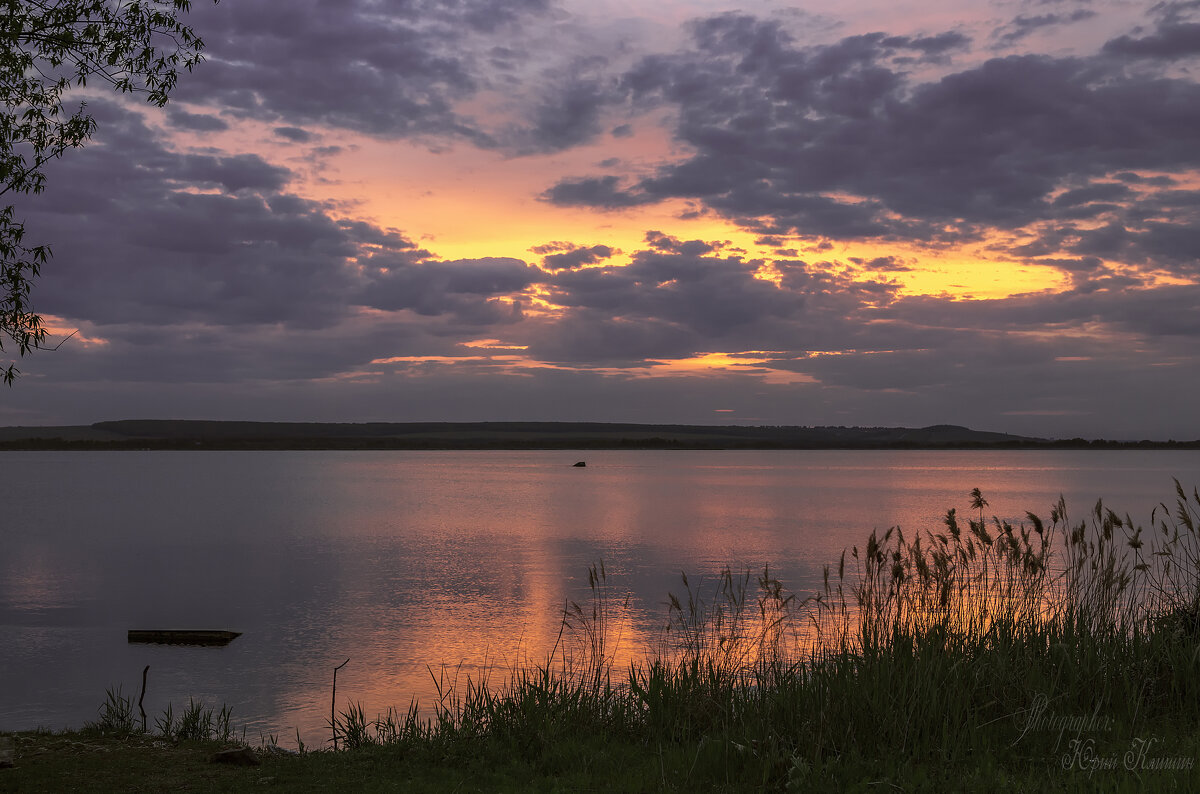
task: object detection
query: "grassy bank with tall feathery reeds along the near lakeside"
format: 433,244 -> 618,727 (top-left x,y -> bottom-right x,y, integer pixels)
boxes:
7,488 -> 1200,792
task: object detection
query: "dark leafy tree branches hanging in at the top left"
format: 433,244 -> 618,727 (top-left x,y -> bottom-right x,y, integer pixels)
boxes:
0,0 -> 217,384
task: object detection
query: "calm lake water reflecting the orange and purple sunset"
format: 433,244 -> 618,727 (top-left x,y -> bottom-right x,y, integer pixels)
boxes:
7,451 -> 1200,746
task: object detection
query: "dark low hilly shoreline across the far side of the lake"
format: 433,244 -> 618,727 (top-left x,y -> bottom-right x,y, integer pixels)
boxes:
0,420 -> 1200,451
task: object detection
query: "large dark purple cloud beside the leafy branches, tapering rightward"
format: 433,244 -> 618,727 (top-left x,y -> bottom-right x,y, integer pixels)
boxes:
20,102 -> 542,339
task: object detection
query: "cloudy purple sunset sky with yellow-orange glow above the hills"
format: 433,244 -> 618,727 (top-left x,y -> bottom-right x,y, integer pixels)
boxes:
0,0 -> 1200,440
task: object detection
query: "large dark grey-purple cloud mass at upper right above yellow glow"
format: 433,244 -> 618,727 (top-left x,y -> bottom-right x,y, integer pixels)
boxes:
544,12 -> 1200,273
